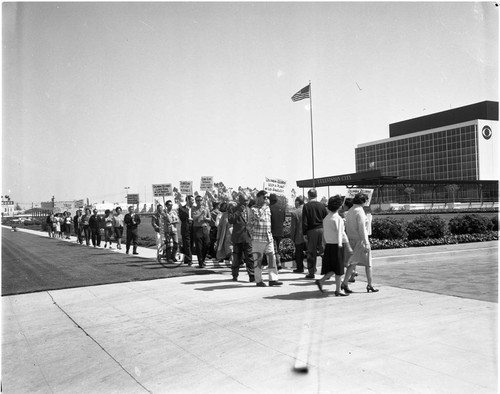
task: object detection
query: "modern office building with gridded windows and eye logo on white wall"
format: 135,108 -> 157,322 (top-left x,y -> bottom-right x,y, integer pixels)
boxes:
355,101 -> 499,203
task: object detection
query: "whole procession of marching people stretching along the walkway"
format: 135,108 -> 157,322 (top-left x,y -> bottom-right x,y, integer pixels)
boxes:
47,189 -> 378,296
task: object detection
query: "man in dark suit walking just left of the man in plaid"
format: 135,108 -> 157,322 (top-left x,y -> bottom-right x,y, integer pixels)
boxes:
228,194 -> 255,282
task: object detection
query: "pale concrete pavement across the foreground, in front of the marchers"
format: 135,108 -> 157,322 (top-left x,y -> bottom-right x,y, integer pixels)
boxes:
2,226 -> 498,394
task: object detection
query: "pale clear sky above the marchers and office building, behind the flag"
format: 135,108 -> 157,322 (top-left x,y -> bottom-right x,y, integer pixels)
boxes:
2,2 -> 499,206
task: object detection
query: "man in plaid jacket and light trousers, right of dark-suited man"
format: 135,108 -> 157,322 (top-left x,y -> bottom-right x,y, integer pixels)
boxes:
252,190 -> 283,287
